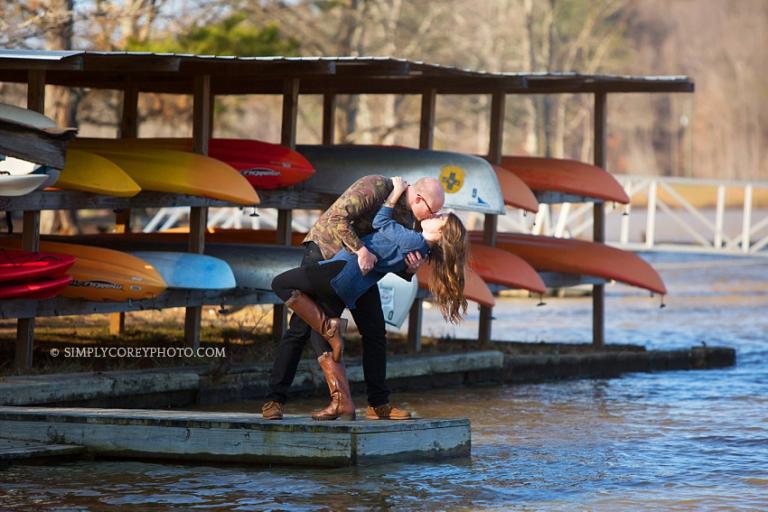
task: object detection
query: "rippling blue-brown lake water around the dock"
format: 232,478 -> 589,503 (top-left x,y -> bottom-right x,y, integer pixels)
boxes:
0,255 -> 768,511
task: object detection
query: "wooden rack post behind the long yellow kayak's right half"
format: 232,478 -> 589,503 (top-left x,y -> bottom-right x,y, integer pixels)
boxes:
184,75 -> 211,349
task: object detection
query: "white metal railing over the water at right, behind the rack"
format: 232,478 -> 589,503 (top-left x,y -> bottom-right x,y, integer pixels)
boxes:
486,176 -> 768,256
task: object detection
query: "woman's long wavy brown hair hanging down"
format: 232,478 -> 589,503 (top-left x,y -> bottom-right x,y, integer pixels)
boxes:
429,213 -> 469,324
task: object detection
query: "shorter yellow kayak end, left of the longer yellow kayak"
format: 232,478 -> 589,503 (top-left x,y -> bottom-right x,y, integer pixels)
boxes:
56,149 -> 141,197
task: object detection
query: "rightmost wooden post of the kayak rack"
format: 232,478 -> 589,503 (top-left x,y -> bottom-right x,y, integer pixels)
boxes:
592,92 -> 607,348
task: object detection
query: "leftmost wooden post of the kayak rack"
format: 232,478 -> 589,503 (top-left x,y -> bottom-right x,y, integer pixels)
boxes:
14,70 -> 45,370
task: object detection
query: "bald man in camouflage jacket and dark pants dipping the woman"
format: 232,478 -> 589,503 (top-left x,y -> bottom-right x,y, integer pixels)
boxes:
262,176 -> 445,420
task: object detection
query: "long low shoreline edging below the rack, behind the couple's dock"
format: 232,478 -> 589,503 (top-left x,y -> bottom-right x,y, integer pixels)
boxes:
0,343 -> 736,409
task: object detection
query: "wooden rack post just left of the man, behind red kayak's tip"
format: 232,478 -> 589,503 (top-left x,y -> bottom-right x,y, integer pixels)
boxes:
272,78 -> 302,340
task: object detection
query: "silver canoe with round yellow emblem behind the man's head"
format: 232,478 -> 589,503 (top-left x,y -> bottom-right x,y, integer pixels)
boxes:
296,146 -> 506,215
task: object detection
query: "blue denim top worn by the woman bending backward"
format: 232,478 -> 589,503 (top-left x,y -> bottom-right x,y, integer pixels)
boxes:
321,206 -> 429,309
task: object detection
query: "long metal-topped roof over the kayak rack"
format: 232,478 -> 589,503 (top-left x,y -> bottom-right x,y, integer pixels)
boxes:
0,49 -> 694,94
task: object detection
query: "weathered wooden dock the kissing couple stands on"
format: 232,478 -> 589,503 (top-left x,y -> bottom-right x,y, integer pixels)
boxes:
0,407 -> 471,466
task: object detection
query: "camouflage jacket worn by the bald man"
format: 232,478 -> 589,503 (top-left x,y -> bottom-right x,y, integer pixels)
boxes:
304,175 -> 416,259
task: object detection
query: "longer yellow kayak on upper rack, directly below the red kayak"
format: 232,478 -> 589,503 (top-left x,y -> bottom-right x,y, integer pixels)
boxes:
78,148 -> 259,205
